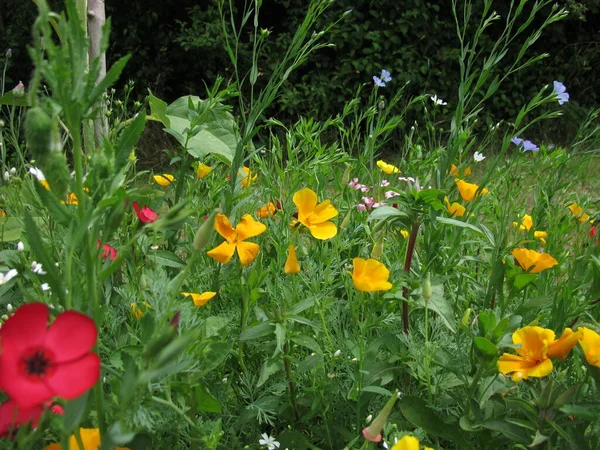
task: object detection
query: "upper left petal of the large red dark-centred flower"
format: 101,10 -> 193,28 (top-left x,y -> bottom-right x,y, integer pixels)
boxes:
0,303 -> 48,353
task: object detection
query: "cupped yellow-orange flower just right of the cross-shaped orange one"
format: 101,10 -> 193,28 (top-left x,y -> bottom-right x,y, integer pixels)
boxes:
293,188 -> 338,240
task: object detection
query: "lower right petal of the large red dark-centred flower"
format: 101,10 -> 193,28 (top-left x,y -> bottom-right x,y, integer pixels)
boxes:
46,353 -> 100,400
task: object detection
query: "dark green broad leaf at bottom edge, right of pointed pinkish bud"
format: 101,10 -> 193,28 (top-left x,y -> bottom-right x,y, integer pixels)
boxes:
400,396 -> 472,449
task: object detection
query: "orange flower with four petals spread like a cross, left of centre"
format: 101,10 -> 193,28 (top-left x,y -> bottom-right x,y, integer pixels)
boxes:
206,214 -> 267,266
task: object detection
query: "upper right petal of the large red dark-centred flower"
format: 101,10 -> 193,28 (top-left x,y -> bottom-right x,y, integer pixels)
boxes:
44,311 -> 98,364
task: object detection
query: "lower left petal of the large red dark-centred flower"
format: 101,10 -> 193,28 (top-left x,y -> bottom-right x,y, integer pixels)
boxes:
0,352 -> 54,409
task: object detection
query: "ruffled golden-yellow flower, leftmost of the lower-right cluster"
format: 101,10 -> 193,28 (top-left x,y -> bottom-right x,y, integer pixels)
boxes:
498,327 -> 554,381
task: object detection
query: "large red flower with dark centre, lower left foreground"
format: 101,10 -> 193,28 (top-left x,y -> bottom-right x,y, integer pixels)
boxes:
0,303 -> 100,410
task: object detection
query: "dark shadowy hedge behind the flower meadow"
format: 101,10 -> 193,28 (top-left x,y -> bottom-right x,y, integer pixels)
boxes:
0,0 -> 600,141
